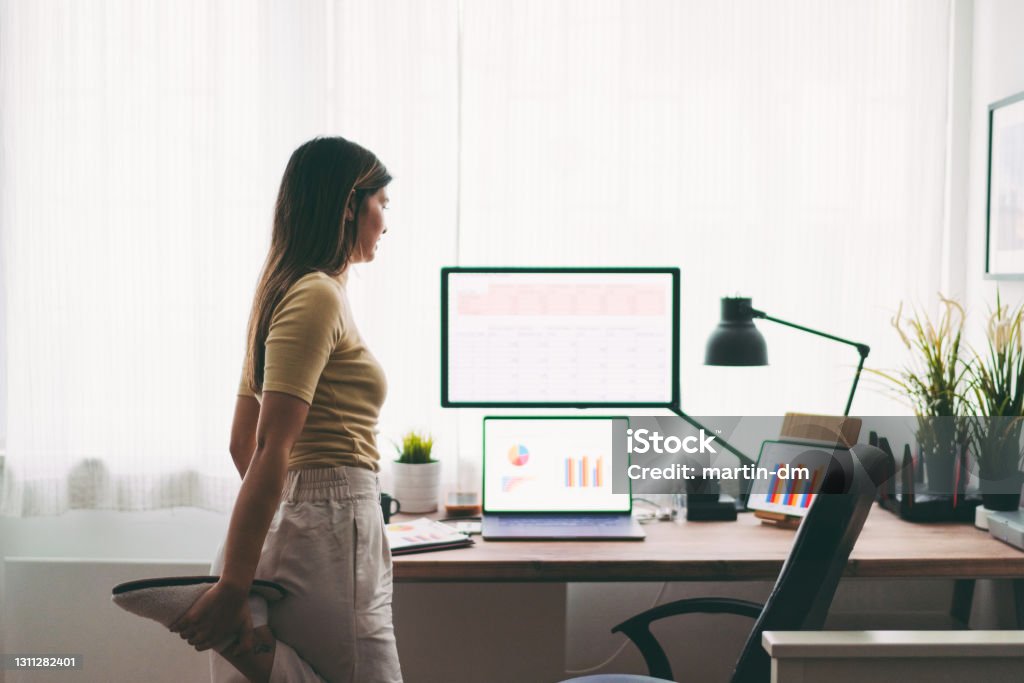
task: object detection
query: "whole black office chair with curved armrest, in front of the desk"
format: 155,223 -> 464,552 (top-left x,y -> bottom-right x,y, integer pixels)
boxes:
563,444 -> 895,683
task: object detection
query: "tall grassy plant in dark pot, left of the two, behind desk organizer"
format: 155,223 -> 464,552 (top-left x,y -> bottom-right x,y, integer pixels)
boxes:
876,295 -> 968,494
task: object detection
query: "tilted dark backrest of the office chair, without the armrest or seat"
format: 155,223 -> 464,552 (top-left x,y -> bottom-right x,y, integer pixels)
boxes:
732,444 -> 895,683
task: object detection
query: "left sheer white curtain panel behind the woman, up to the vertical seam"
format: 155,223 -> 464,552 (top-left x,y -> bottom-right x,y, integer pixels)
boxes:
0,0 -> 458,514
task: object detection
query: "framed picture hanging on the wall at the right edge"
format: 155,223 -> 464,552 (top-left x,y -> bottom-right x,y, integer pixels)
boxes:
985,92 -> 1024,280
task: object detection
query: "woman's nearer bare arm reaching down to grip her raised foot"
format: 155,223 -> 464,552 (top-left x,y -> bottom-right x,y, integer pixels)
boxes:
171,391 -> 309,650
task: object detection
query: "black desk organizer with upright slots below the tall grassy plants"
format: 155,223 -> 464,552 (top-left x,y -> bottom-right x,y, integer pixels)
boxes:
868,432 -> 981,523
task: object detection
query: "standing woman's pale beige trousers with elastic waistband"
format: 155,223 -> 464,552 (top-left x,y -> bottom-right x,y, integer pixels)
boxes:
211,467 -> 401,683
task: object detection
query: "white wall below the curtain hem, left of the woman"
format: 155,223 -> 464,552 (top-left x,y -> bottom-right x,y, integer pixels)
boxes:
0,508 -> 227,683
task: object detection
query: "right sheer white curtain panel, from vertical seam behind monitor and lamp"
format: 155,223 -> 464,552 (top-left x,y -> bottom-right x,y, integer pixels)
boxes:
460,0 -> 949,415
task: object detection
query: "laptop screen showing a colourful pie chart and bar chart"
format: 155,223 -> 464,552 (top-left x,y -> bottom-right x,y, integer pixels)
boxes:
483,417 -> 632,513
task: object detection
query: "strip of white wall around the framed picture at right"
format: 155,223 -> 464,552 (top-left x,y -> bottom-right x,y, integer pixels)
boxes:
964,0 -> 1024,323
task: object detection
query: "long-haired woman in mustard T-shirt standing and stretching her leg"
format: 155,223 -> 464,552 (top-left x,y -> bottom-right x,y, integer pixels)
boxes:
171,137 -> 401,683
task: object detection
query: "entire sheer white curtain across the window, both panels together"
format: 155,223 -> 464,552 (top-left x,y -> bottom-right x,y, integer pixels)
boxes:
0,0 -> 948,514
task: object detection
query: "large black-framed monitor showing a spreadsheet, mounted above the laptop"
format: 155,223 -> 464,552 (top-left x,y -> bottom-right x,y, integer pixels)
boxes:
441,267 -> 679,408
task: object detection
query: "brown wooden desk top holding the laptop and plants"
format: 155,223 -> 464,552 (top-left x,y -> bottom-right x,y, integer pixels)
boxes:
394,506 -> 1024,582
